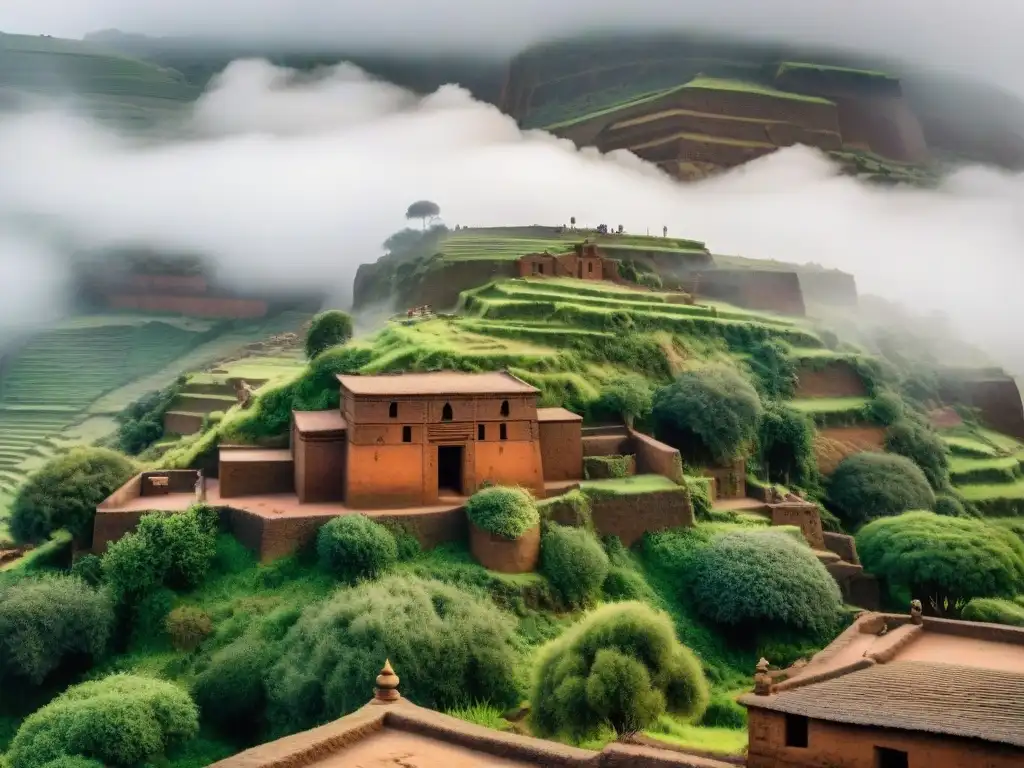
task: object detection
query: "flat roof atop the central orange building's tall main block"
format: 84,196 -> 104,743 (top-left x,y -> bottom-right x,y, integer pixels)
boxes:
338,371 -> 540,397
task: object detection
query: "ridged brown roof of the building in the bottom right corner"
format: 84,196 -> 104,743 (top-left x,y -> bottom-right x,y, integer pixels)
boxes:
739,613 -> 1024,746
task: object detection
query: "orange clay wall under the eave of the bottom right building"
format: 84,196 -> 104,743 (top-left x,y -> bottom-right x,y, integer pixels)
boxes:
746,708 -> 1024,768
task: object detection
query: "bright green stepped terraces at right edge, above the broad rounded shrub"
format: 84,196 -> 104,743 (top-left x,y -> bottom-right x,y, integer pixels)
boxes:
942,425 -> 1024,516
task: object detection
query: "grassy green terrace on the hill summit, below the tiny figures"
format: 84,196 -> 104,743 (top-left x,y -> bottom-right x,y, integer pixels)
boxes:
439,226 -> 706,261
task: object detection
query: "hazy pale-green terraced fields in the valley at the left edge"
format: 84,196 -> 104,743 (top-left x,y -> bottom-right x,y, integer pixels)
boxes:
0,312 -> 308,540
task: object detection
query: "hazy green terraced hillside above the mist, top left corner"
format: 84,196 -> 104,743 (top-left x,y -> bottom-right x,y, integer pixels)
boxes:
0,34 -> 200,127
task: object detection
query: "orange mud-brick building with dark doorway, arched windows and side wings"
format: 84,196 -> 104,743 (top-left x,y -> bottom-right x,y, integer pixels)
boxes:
219,371 -> 583,510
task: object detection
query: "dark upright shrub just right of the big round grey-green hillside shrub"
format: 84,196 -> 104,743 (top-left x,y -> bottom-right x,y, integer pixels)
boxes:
758,404 -> 818,487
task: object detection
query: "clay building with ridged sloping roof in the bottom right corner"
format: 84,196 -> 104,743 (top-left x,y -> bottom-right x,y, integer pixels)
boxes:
740,613 -> 1024,768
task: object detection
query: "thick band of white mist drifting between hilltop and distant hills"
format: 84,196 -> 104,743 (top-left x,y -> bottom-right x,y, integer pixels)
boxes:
0,61 -> 1024,371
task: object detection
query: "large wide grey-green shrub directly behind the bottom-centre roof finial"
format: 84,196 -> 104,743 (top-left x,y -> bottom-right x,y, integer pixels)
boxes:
267,575 -> 522,730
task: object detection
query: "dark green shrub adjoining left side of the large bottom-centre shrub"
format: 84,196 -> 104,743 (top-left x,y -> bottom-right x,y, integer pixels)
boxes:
191,638 -> 272,735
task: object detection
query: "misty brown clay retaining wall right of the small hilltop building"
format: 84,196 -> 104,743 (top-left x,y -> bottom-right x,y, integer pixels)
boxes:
691,269 -> 807,316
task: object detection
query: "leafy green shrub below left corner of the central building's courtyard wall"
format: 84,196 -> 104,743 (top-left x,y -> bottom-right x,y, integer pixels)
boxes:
103,505 -> 217,601
